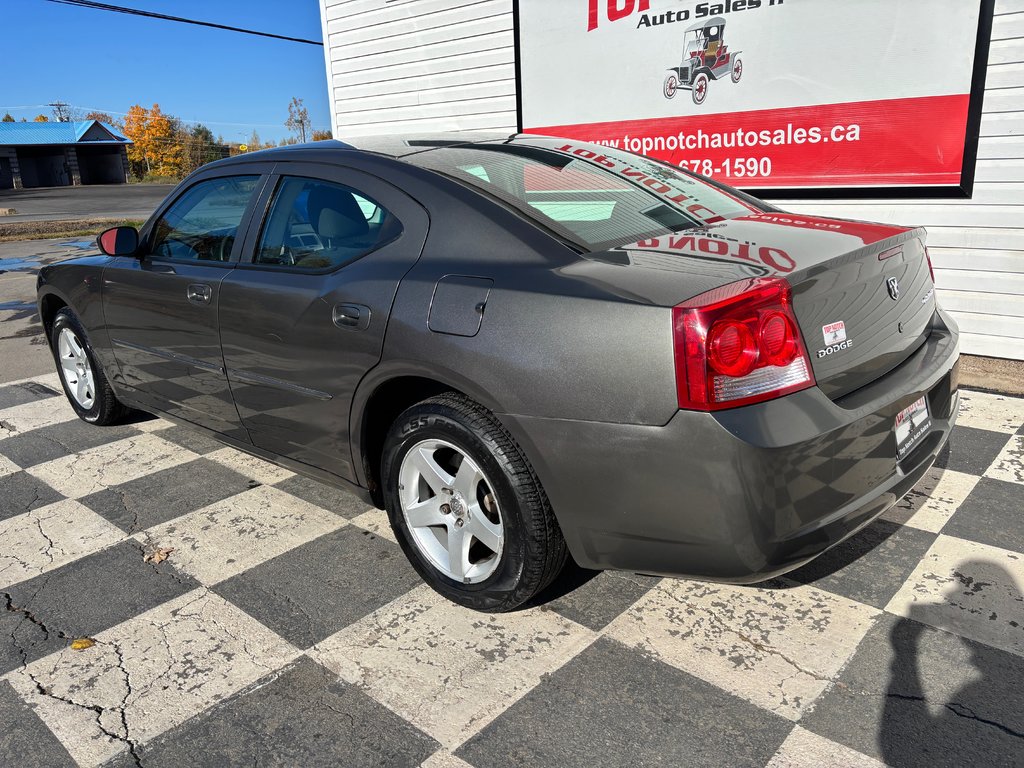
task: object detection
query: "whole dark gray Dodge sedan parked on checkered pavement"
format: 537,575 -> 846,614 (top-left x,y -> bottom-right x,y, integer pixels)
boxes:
38,135 -> 957,610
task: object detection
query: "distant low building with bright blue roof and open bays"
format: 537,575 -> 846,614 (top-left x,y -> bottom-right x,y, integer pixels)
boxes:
0,120 -> 132,189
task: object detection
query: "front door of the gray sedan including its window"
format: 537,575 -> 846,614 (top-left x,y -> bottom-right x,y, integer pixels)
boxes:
103,168 -> 265,441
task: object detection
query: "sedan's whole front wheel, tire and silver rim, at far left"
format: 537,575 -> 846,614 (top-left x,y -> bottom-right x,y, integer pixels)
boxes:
50,307 -> 125,426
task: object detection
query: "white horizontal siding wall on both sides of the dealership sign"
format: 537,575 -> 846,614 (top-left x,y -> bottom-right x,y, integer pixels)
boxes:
321,0 -> 1024,359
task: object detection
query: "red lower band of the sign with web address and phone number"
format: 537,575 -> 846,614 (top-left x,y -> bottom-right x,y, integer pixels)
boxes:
525,94 -> 970,188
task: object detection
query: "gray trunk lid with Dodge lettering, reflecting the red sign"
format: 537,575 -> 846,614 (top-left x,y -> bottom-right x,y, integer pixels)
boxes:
577,212 -> 935,399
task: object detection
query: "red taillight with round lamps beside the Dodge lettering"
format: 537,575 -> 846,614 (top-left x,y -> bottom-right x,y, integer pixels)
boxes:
673,278 -> 814,411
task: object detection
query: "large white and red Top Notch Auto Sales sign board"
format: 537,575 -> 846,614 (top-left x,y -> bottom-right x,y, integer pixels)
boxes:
516,0 -> 992,195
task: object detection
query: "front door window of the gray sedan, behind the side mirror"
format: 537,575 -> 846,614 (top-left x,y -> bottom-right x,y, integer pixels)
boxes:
151,176 -> 259,261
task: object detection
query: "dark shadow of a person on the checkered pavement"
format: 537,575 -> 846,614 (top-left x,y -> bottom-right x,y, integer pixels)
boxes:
879,562 -> 1024,768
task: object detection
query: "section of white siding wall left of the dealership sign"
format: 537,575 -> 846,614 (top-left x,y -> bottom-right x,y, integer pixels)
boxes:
321,0 -> 516,138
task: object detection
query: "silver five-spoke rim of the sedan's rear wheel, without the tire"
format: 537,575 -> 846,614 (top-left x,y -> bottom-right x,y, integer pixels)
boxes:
398,440 -> 505,584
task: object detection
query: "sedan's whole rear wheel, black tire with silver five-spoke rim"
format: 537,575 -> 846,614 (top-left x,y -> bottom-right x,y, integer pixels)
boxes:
381,393 -> 567,612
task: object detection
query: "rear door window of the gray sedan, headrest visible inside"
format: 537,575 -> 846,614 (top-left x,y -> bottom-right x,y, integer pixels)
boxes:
255,176 -> 401,271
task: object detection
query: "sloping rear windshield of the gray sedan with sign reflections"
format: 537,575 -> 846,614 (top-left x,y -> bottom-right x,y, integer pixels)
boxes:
407,141 -> 764,252
